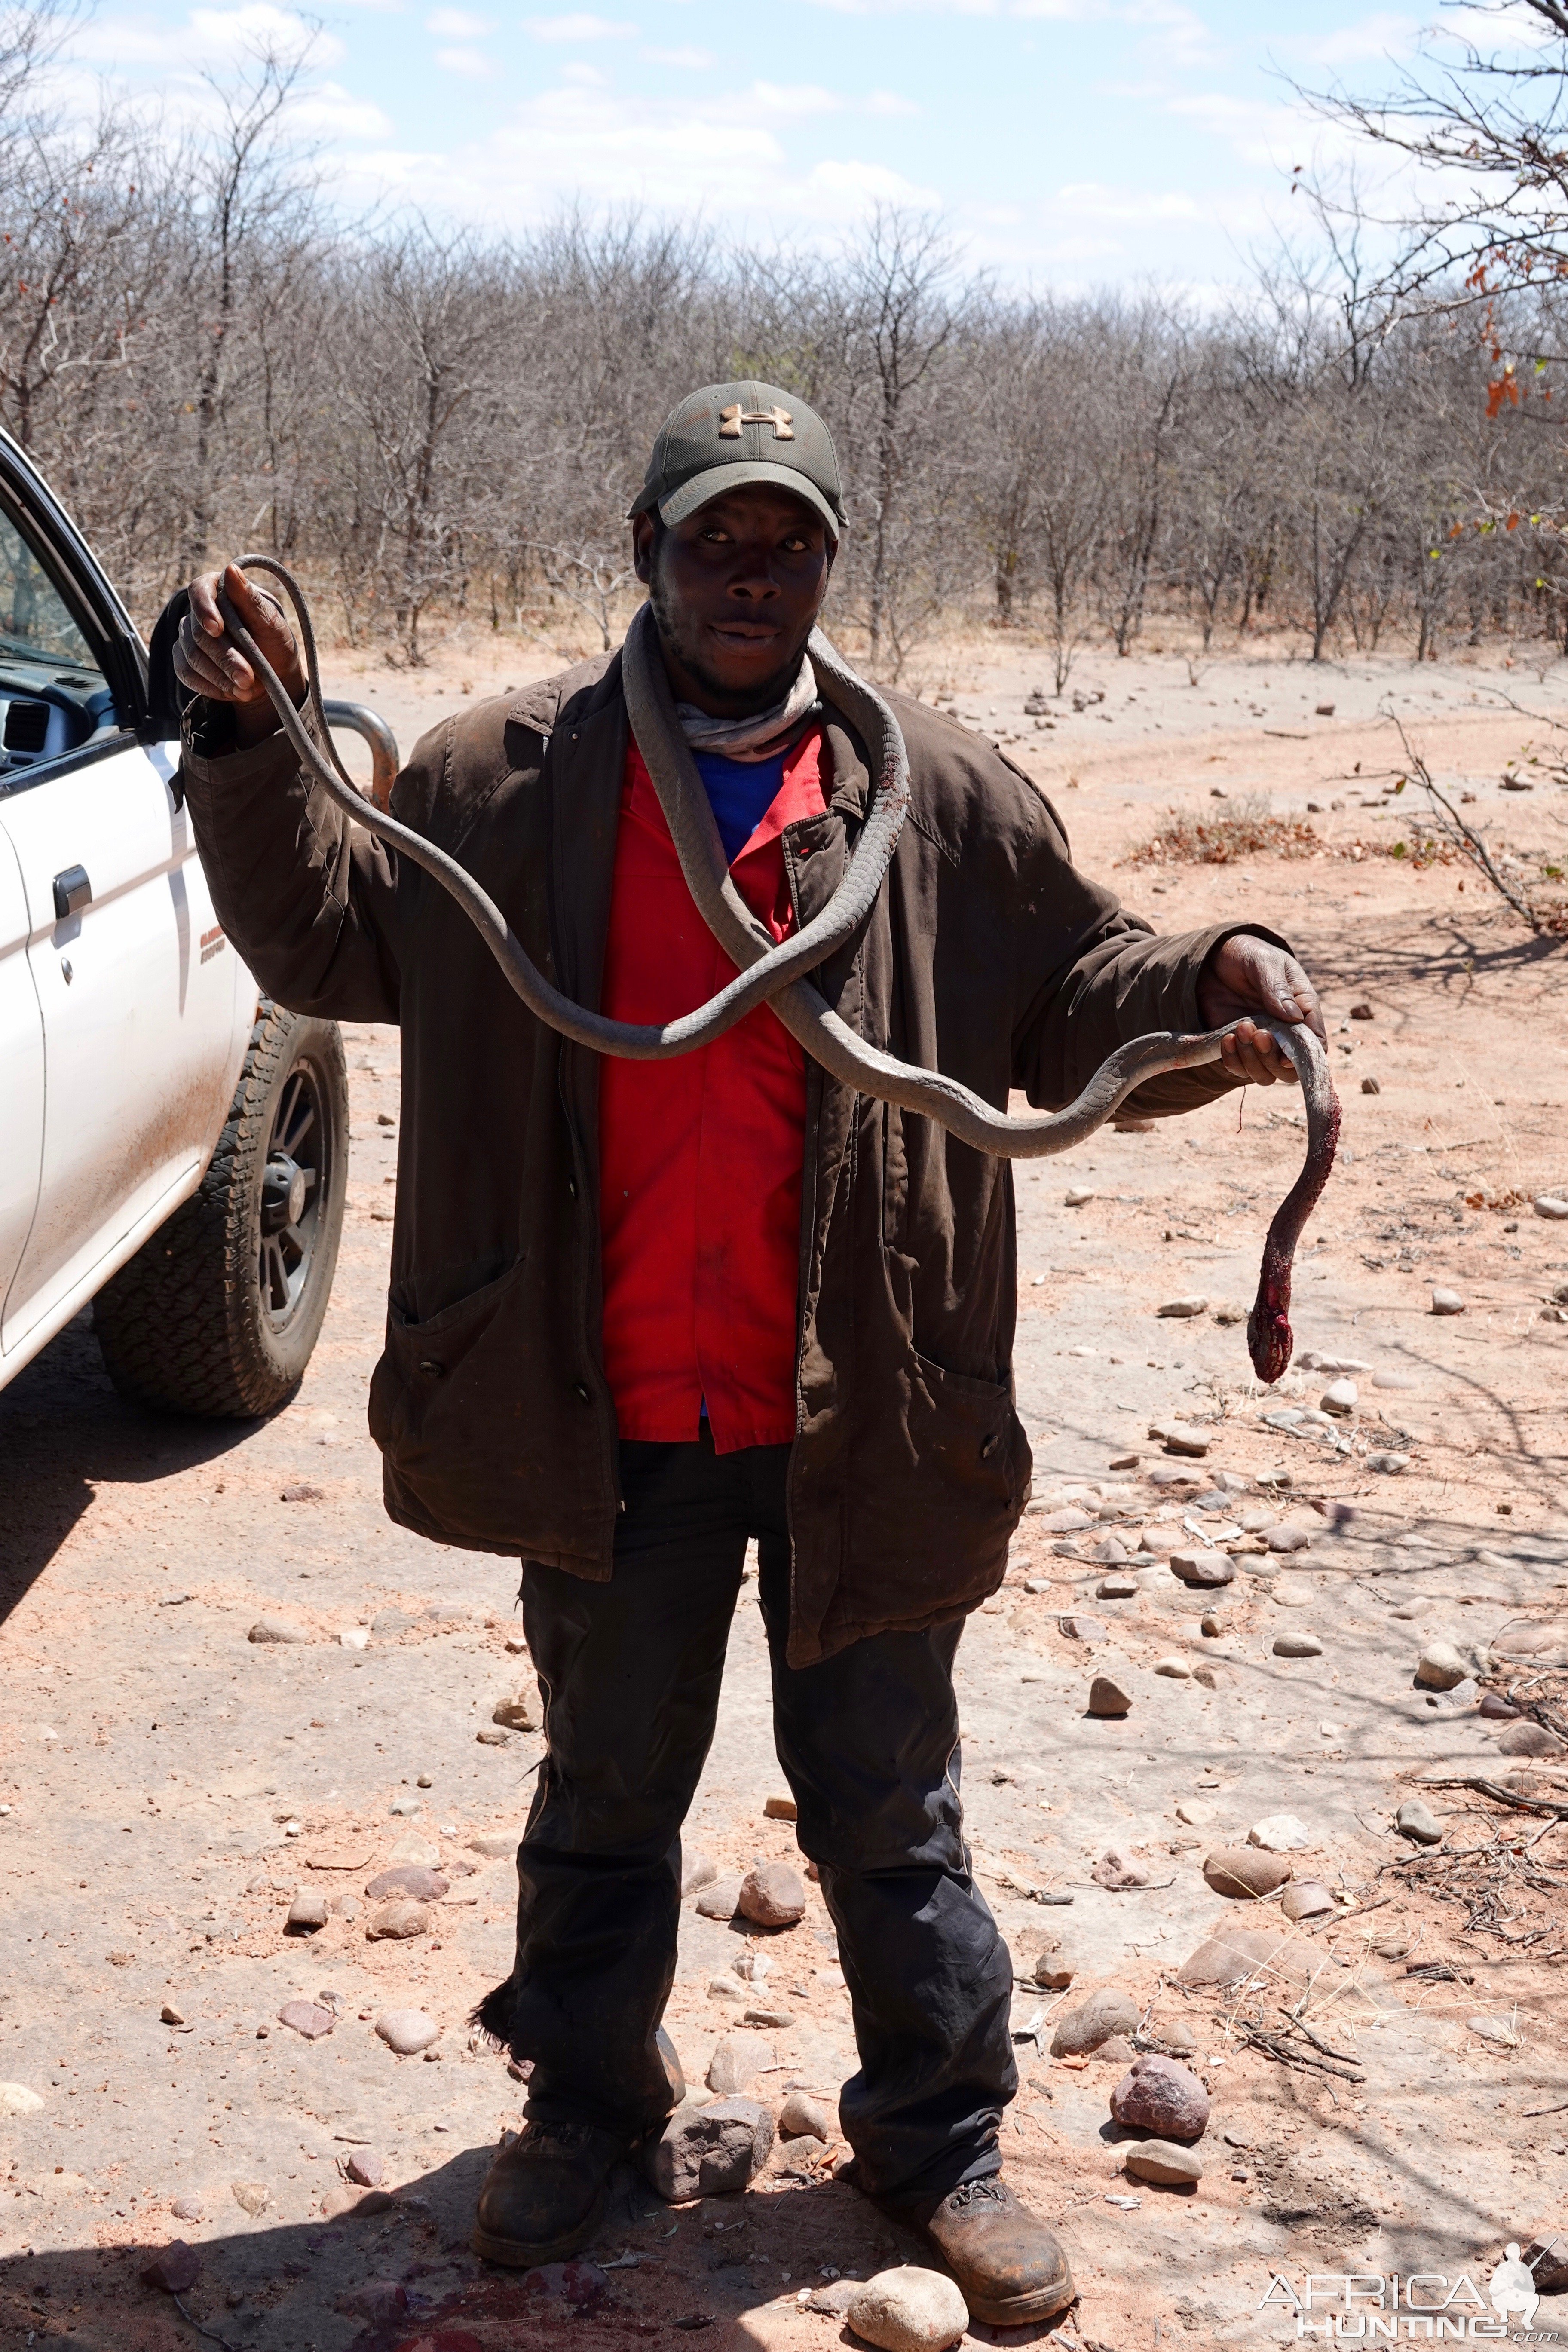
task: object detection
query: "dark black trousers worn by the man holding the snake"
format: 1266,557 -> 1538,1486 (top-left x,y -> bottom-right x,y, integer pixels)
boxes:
496,1432 -> 1018,2199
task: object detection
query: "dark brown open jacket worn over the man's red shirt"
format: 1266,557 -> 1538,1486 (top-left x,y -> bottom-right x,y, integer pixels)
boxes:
184,656 -> 1267,1665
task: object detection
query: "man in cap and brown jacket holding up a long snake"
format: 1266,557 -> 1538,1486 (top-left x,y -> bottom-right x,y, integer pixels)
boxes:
176,383 -> 1321,2324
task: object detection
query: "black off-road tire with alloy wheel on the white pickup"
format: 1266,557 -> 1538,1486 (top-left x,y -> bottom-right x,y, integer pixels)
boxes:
92,997 -> 348,1418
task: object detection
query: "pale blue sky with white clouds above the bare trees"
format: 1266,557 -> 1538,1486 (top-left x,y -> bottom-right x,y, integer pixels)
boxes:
61,0 -> 1495,292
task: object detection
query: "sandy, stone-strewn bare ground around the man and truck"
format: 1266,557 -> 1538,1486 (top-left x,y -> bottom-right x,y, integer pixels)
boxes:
0,625 -> 1568,2352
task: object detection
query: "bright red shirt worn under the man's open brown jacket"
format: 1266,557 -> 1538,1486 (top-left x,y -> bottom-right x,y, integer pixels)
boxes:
600,729 -> 825,1454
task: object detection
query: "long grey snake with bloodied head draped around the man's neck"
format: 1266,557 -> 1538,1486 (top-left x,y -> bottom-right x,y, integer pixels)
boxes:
208,555 -> 1340,1385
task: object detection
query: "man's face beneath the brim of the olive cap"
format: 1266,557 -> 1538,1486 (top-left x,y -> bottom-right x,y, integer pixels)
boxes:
632,482 -> 832,717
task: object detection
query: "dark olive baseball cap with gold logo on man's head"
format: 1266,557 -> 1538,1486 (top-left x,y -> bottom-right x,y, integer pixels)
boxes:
630,383 -> 844,539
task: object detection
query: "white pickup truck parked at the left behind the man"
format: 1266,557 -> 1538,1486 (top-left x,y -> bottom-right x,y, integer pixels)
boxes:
0,435 -> 395,1416
